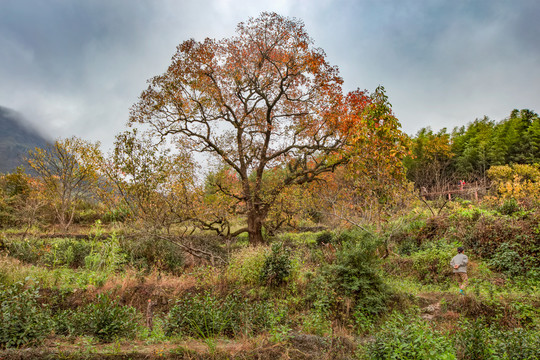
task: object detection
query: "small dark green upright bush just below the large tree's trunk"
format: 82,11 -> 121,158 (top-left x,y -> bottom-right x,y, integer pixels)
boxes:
259,243 -> 292,287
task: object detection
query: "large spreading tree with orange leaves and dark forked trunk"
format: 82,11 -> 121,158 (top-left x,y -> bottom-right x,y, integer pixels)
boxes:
130,13 -> 400,243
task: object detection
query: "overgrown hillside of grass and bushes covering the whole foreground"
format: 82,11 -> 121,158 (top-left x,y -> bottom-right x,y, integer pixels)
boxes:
0,202 -> 540,359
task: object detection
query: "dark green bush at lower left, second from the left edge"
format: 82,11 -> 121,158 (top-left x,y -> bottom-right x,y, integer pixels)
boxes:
68,294 -> 139,342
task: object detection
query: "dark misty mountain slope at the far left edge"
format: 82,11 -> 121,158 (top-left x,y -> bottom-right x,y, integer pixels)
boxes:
0,106 -> 49,174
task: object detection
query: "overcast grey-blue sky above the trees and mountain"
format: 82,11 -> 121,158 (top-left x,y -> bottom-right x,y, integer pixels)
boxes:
0,0 -> 540,149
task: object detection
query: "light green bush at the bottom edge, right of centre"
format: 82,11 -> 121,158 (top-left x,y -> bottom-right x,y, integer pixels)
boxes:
367,314 -> 456,360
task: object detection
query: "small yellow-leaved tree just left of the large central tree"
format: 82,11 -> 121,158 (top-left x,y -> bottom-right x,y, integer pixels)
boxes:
101,130 -> 198,231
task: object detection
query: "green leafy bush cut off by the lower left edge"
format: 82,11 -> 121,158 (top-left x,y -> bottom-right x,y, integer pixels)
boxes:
0,283 -> 51,348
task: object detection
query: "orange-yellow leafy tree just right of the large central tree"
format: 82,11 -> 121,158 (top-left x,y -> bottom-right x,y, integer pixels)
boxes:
307,87 -> 409,228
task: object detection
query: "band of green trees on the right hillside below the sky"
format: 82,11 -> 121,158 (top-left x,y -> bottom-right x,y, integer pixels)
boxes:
405,109 -> 540,191
